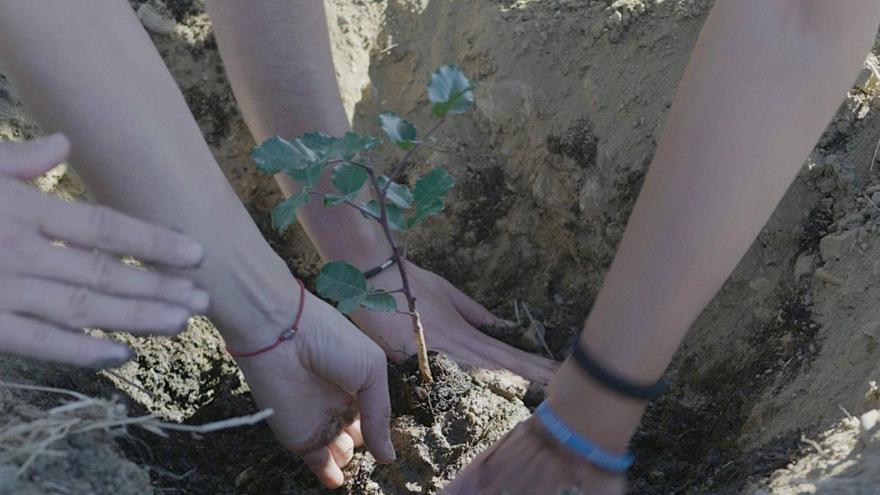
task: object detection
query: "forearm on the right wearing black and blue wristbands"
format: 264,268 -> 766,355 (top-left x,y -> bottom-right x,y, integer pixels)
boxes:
551,0 -> 880,454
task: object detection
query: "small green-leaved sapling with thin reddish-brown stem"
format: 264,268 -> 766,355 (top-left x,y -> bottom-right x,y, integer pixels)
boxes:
251,65 -> 474,383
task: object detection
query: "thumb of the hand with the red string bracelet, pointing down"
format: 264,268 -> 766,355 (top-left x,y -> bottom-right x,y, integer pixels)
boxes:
357,366 -> 397,463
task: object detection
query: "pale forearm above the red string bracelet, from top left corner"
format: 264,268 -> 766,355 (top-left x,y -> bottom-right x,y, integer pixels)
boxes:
0,0 -> 296,348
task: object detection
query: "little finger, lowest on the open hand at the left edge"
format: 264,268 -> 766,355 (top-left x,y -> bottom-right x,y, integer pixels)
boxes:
0,314 -> 133,369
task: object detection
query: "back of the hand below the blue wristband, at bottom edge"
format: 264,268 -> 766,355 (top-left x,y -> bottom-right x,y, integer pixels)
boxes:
442,418 -> 625,495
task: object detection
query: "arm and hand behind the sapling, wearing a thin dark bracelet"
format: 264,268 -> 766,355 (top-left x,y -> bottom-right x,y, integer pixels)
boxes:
207,0 -> 556,383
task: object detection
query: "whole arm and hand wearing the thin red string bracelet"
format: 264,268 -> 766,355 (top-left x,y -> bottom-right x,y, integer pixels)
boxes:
0,0 -> 394,486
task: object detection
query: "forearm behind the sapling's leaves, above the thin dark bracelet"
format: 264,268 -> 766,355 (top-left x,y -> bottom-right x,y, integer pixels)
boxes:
206,0 -> 390,268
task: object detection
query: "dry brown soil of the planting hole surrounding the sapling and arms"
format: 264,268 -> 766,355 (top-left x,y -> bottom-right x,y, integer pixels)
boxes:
0,0 -> 880,495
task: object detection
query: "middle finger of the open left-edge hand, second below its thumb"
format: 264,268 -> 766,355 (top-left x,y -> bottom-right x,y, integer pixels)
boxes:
35,243 -> 209,314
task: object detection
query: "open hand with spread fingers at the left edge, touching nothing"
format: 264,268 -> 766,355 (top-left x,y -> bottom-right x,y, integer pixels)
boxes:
0,134 -> 208,368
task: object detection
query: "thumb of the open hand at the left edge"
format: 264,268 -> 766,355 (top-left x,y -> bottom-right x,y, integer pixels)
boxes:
0,133 -> 70,180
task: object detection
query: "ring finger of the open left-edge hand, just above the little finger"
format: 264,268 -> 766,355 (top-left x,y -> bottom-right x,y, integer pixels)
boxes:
6,277 -> 190,334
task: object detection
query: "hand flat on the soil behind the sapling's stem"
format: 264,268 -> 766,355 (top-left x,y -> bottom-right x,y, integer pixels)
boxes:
352,262 -> 557,385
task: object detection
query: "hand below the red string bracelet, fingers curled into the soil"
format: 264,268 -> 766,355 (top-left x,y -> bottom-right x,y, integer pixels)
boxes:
237,292 -> 395,488
